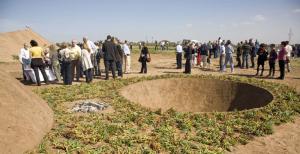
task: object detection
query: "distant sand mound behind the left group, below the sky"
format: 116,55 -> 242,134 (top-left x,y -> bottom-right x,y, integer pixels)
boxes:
0,29 -> 49,62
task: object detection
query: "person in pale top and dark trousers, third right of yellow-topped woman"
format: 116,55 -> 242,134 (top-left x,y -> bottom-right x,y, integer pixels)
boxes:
60,42 -> 73,85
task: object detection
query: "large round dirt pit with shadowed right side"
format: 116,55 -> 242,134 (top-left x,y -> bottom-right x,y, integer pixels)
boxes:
121,78 -> 273,112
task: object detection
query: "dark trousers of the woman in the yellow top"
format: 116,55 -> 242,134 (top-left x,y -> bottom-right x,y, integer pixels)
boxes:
31,58 -> 49,86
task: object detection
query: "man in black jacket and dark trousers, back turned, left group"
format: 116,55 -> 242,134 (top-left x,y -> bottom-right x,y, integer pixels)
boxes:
102,35 -> 117,80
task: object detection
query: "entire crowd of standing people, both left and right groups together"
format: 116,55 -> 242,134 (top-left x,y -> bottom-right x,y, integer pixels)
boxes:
19,35 -> 296,86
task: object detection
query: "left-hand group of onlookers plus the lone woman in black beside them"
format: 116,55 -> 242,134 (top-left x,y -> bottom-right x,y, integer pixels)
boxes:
19,35 -> 134,86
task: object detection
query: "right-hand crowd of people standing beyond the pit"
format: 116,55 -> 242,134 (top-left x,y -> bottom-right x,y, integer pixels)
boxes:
176,38 -> 297,79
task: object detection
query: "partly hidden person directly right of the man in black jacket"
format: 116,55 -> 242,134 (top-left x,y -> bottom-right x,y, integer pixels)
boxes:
113,38 -> 124,78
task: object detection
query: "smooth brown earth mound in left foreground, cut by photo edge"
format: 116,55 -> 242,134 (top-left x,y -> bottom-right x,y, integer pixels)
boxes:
0,69 -> 53,153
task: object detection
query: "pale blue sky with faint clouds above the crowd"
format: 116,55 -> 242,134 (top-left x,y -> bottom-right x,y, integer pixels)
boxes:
0,0 -> 300,43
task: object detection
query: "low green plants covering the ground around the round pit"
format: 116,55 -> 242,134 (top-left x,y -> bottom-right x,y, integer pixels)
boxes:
32,75 -> 300,153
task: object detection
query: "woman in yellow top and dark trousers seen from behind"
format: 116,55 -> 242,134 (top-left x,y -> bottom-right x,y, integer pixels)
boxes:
29,40 -> 49,86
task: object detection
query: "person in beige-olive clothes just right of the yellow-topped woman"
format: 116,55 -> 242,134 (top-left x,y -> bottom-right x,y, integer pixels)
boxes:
49,44 -> 61,82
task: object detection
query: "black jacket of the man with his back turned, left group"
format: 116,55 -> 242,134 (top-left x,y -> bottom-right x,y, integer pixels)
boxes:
102,40 -> 117,61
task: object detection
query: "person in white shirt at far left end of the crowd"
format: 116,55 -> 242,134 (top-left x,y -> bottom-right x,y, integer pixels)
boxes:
19,43 -> 31,81
